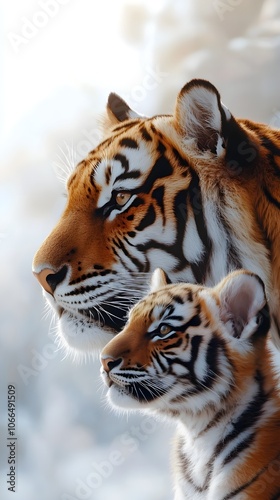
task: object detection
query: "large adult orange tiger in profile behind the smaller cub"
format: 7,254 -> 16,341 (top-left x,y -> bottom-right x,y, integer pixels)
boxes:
33,80 -> 280,352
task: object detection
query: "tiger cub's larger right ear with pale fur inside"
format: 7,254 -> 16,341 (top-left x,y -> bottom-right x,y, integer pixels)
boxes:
216,271 -> 270,339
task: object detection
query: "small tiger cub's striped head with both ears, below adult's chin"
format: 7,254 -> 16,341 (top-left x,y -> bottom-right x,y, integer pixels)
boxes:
101,269 -> 270,415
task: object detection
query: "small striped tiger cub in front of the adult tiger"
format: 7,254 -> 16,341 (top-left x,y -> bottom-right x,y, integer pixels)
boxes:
101,269 -> 280,500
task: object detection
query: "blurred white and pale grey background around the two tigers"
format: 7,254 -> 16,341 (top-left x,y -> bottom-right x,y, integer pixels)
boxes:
0,0 -> 280,500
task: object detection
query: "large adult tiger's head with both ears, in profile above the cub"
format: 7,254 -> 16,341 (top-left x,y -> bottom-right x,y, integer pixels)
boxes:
33,80 -> 260,352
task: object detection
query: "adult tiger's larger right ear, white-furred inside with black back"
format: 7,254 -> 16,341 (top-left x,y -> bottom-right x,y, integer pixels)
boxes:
175,80 -> 257,167
